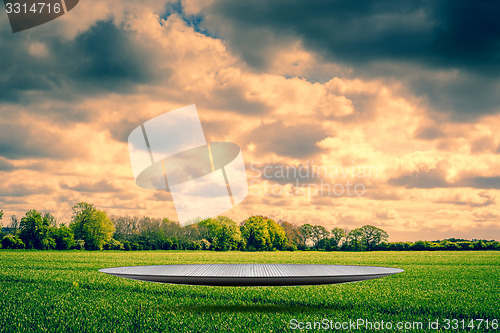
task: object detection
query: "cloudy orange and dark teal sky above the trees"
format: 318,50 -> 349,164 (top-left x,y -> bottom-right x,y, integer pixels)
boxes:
0,0 -> 500,241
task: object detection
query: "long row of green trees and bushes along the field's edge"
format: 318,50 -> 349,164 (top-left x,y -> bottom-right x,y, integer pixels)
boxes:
0,202 -> 500,251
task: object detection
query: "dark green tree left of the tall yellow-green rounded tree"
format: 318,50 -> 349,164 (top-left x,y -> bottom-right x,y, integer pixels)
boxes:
19,209 -> 55,250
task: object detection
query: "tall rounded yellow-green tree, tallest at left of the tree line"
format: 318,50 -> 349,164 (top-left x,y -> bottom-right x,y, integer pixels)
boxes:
70,202 -> 115,250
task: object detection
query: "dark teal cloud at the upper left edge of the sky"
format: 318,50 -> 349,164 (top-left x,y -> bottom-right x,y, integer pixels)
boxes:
0,20 -> 160,105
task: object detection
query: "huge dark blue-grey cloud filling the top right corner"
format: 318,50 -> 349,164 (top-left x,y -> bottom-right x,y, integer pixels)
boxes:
201,0 -> 500,120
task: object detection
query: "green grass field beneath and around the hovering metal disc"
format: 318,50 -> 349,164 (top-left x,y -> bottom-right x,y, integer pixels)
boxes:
0,251 -> 500,332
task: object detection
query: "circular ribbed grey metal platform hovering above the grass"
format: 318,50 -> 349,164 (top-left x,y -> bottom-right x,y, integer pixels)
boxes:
99,264 -> 403,287
